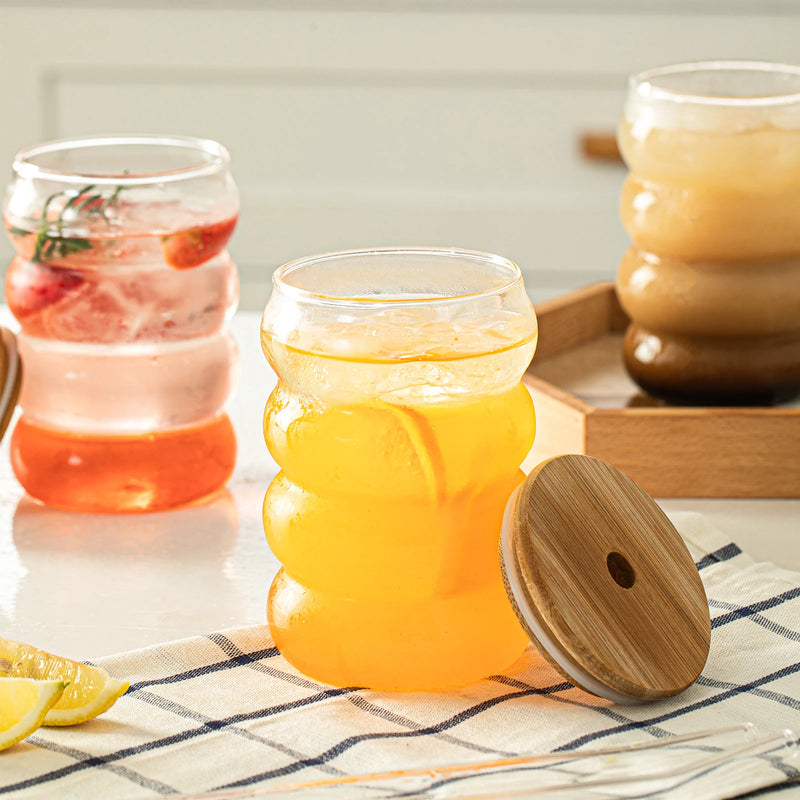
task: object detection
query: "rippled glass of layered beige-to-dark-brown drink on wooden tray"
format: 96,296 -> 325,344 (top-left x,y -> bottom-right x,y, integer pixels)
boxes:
617,61 -> 800,404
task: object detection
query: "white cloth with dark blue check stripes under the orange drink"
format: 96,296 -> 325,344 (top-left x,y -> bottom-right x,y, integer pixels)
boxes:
0,515 -> 800,800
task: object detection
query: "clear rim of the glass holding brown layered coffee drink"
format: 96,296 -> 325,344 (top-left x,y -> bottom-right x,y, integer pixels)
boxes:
628,60 -> 800,108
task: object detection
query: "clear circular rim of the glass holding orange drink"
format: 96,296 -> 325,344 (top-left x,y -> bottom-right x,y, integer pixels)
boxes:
272,246 -> 522,308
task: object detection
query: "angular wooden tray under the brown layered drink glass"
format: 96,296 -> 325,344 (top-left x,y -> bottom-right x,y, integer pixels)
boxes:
525,283 -> 800,497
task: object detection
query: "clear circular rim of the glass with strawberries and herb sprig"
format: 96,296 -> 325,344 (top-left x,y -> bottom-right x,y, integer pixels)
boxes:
13,134 -> 230,186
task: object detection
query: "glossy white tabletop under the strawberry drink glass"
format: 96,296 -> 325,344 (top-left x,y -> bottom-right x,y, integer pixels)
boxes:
0,309 -> 800,659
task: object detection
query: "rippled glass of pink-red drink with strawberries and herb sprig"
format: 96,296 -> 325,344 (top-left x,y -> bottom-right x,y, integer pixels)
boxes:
3,136 -> 239,512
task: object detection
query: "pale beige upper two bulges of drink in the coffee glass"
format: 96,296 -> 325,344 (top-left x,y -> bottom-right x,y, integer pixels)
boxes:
619,119 -> 800,261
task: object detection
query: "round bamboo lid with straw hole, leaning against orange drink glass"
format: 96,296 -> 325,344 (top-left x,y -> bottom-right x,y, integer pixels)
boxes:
500,455 -> 711,703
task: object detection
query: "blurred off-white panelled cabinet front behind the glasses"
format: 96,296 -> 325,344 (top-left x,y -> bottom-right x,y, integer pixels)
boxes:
0,0 -> 800,308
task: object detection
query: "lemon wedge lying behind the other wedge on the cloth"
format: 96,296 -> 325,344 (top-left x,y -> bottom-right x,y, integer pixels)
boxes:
0,637 -> 130,725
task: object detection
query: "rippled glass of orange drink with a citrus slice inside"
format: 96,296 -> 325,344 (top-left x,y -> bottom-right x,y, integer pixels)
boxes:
261,248 -> 537,690
